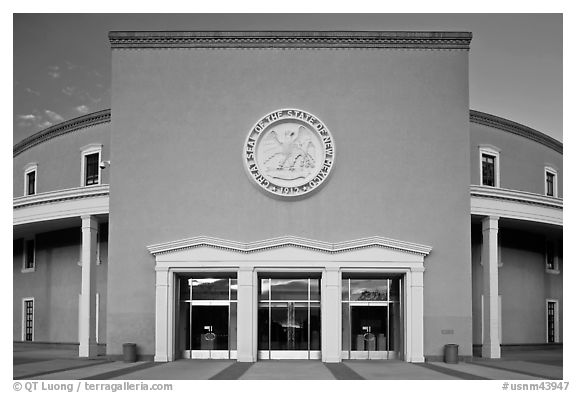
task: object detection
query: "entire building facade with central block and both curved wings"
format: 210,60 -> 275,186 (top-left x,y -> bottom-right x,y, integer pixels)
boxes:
13,32 -> 563,362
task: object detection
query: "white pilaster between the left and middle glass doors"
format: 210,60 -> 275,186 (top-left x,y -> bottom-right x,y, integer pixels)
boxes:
236,266 -> 257,362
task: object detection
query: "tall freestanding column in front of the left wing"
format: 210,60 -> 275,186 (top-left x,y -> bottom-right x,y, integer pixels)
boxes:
78,216 -> 98,357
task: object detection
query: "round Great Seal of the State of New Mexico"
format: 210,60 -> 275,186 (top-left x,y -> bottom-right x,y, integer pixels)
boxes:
244,109 -> 335,197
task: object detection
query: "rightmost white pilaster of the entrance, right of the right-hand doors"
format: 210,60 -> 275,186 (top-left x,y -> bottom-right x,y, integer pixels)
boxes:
408,267 -> 424,363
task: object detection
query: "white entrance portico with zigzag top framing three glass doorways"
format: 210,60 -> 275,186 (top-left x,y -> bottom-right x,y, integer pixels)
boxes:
148,237 -> 431,362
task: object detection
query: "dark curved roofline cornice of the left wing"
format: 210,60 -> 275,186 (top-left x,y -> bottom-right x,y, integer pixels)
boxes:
12,109 -> 110,157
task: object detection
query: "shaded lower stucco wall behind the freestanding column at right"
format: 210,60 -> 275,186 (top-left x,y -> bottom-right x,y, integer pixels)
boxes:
472,226 -> 563,344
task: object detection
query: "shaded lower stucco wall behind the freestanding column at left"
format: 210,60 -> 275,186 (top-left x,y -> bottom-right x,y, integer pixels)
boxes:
12,225 -> 108,343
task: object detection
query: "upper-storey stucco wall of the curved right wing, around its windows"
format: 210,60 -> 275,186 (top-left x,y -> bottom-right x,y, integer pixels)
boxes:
470,123 -> 564,197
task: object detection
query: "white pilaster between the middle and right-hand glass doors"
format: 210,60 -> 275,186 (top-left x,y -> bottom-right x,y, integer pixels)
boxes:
320,267 -> 342,363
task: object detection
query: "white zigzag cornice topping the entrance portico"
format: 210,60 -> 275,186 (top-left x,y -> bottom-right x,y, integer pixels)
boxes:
147,236 -> 432,256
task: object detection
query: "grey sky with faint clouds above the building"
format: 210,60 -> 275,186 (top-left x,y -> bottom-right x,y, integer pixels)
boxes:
13,14 -> 563,143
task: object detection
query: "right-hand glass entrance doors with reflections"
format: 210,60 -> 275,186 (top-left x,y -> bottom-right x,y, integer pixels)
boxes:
342,277 -> 403,359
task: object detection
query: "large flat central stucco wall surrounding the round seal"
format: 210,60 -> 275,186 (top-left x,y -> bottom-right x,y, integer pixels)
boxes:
108,49 -> 472,355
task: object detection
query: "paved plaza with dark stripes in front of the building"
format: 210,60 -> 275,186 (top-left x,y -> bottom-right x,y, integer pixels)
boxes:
13,348 -> 563,380
